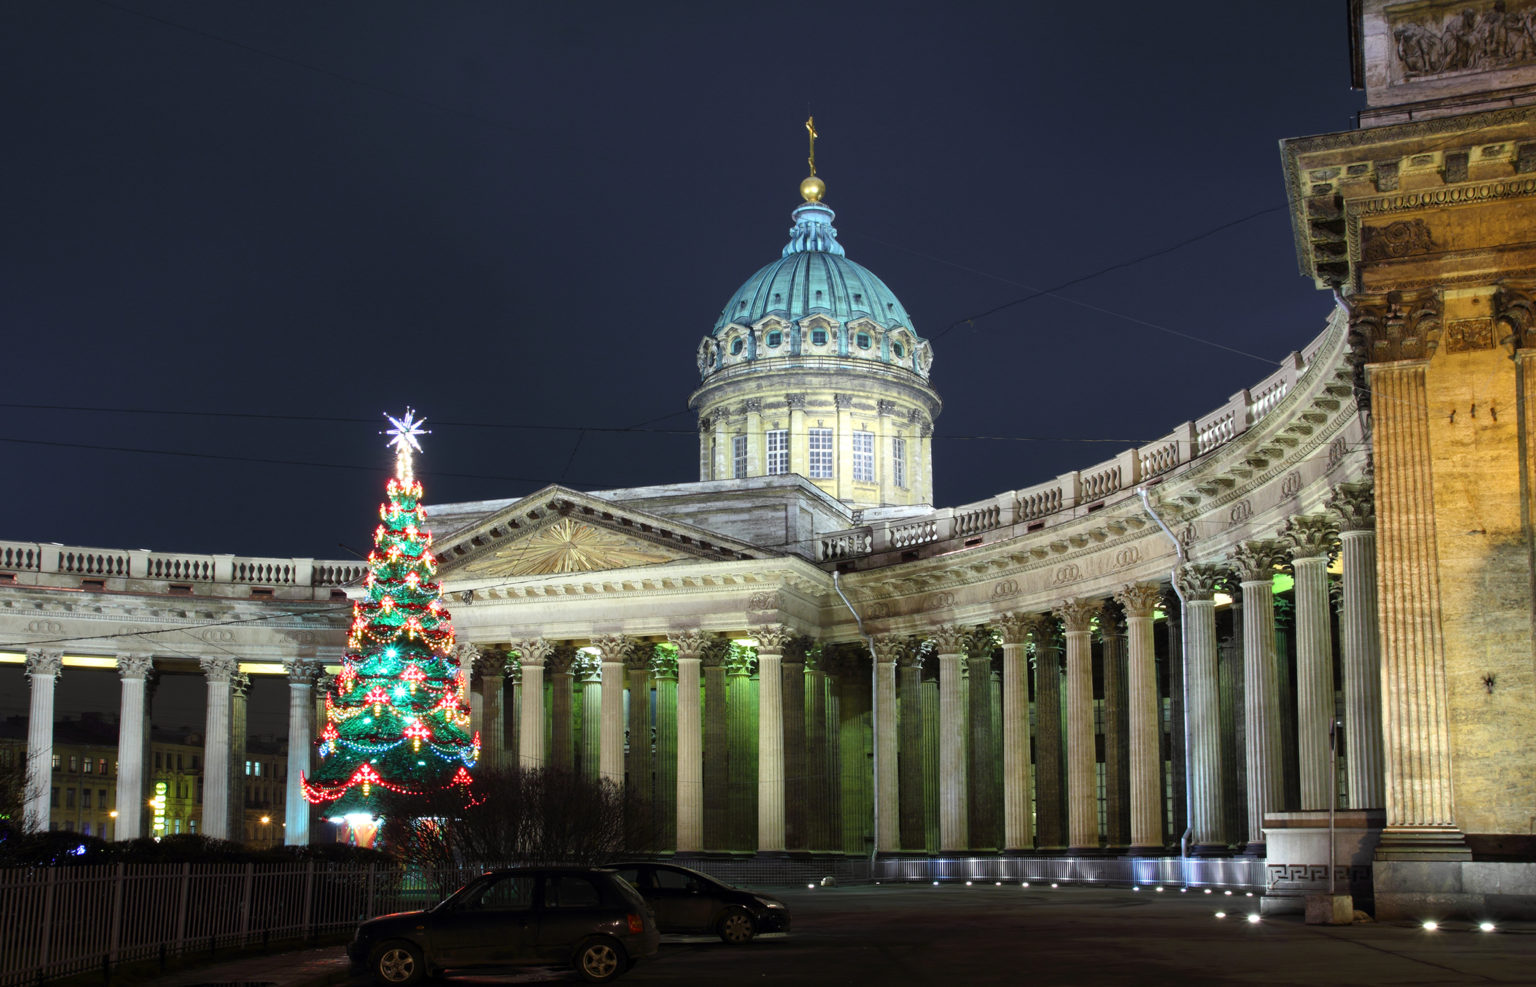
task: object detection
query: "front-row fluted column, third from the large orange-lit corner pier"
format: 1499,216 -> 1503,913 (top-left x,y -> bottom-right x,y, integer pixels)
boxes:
1229,539 -> 1286,855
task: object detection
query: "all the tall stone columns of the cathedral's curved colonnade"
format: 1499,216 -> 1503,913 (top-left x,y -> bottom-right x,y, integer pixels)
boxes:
26,482 -> 1385,853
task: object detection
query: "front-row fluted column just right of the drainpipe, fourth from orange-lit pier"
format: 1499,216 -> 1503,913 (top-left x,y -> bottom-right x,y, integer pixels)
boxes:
1178,562 -> 1226,853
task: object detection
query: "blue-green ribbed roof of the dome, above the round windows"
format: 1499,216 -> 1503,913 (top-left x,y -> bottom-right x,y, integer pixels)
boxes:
713,203 -> 912,336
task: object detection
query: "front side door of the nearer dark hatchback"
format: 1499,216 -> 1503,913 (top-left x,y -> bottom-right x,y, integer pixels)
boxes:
432,873 -> 538,967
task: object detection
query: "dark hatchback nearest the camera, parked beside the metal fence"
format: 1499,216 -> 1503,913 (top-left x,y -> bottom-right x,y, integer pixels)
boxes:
347,867 -> 659,985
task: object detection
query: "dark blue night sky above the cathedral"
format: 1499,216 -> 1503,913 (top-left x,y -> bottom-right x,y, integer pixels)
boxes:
0,0 -> 1362,733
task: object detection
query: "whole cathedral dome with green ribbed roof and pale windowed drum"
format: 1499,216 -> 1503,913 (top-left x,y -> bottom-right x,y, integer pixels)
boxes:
688,164 -> 942,510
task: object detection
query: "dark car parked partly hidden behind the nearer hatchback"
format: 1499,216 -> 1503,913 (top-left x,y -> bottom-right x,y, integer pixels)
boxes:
608,861 -> 790,946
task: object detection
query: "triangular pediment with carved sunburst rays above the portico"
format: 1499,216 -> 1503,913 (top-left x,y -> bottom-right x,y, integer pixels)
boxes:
438,487 -> 768,580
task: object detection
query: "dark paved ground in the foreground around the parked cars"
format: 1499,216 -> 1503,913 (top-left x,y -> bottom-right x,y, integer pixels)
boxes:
122,884 -> 1536,987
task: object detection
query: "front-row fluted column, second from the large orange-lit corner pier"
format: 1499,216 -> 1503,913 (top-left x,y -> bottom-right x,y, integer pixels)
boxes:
1284,514 -> 1338,809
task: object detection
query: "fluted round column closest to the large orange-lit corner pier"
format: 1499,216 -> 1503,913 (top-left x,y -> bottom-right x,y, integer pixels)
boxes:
1329,480 -> 1387,809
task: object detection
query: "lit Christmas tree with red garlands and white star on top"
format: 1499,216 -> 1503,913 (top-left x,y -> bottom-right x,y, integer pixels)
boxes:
303,408 -> 479,817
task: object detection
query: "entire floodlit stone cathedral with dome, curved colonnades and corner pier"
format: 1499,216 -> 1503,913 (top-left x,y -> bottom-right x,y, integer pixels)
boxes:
9,0 -> 1536,918
